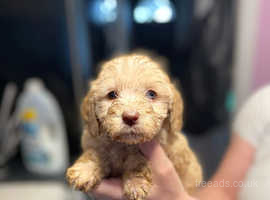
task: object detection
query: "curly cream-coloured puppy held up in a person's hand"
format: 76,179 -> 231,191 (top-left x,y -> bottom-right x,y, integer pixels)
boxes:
67,54 -> 202,200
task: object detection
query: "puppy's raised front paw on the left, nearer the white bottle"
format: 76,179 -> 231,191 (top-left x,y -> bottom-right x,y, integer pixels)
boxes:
66,162 -> 101,192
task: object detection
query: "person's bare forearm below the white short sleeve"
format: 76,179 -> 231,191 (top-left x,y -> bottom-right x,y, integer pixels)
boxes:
196,134 -> 255,200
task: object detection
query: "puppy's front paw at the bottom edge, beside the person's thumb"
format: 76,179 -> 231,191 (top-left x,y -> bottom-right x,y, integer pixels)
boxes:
124,177 -> 152,200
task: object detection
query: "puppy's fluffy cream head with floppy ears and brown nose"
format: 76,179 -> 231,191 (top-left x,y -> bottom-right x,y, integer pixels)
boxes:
82,54 -> 183,144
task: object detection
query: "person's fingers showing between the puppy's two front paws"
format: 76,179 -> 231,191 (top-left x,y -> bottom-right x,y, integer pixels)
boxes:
92,178 -> 123,200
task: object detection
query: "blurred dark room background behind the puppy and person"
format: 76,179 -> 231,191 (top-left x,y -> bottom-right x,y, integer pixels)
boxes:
0,0 -> 270,200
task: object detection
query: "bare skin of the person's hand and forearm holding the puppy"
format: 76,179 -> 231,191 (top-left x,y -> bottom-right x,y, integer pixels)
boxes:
90,134 -> 256,200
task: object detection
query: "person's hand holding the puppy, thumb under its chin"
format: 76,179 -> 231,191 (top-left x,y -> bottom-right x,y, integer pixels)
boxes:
90,141 -> 194,200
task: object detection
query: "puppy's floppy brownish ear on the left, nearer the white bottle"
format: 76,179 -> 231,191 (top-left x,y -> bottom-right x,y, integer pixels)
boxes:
81,90 -> 99,136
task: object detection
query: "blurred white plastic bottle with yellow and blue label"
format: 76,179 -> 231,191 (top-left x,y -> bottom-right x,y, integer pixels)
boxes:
17,78 -> 68,175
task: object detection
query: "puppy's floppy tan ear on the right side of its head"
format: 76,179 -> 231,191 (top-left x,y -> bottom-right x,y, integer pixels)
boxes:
169,84 -> 183,133
